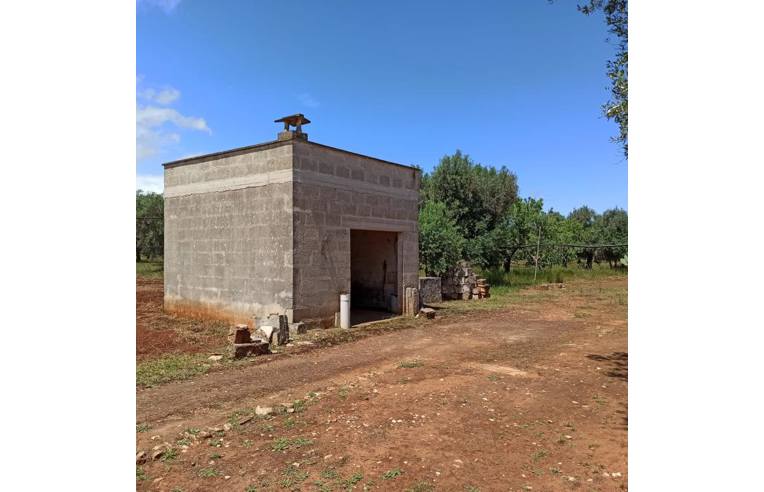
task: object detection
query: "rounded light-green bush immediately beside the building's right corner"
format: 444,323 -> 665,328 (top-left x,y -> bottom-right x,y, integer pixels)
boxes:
419,201 -> 464,276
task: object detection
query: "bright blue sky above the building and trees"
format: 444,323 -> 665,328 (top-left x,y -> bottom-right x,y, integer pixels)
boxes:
136,0 -> 627,213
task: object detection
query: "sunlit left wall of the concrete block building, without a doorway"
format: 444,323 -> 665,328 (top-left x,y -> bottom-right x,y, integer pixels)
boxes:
164,143 -> 294,323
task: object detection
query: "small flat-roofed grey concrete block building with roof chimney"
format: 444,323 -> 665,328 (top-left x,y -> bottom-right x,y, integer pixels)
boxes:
164,115 -> 421,326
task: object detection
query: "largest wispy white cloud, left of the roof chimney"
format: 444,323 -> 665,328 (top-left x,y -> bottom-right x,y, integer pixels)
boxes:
135,75 -> 212,161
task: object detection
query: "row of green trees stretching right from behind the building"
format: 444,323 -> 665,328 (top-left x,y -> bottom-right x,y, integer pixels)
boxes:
419,150 -> 628,275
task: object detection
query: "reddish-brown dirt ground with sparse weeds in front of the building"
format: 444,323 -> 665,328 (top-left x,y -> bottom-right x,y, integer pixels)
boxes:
136,278 -> 628,492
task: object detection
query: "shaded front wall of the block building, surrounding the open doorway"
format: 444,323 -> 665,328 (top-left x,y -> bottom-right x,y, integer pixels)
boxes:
293,142 -> 421,326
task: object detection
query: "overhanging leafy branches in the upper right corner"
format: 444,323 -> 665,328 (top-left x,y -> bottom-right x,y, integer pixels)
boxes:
578,0 -> 629,157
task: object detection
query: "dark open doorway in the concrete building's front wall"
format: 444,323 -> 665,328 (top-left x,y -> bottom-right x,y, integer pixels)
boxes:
350,230 -> 400,325
